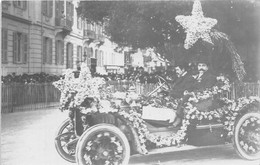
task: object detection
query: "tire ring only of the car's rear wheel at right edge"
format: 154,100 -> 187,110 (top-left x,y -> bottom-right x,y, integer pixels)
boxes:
232,112 -> 260,160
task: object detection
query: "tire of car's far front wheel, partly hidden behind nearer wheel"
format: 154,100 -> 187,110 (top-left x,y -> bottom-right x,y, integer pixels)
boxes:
54,119 -> 76,163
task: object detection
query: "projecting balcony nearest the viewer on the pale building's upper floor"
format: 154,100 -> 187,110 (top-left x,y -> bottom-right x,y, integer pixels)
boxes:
55,18 -> 72,36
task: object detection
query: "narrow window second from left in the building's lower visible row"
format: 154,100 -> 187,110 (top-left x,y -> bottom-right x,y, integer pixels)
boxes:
42,37 -> 52,64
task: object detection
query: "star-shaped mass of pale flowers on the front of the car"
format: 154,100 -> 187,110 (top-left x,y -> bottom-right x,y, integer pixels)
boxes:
53,63 -> 109,110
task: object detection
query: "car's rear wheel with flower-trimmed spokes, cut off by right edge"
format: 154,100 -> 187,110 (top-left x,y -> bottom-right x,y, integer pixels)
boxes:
233,112 -> 260,160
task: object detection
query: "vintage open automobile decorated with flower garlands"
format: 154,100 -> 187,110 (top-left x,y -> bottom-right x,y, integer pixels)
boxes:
55,66 -> 260,165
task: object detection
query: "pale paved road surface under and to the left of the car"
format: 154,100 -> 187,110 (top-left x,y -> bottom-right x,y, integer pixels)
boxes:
1,109 -> 260,165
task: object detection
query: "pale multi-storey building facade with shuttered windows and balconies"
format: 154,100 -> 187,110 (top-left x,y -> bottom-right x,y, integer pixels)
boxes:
1,0 -> 124,76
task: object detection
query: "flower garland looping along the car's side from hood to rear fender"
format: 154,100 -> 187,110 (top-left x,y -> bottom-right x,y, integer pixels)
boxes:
114,76 -> 260,153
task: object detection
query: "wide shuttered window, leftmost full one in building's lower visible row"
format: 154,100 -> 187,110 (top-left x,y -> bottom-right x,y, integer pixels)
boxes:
13,32 -> 28,64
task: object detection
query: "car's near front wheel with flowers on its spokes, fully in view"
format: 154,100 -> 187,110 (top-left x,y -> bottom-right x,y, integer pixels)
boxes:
76,124 -> 130,165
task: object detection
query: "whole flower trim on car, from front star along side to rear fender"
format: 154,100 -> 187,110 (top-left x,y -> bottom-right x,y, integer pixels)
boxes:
54,66 -> 260,154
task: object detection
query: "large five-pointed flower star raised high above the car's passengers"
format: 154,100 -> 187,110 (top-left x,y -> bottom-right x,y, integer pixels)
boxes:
175,0 -> 218,49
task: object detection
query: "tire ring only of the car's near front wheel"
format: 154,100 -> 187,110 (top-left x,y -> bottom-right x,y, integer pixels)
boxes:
76,123 -> 130,165
